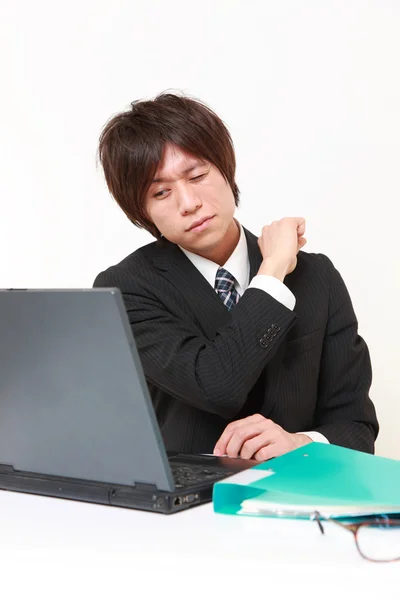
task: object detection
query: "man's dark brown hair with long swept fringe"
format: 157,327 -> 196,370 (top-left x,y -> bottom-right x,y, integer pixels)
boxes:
99,93 -> 239,238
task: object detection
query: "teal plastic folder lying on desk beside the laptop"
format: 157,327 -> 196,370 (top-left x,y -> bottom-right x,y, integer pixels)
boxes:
213,442 -> 400,518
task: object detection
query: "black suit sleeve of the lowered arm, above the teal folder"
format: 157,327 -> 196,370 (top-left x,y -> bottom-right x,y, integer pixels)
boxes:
315,255 -> 379,453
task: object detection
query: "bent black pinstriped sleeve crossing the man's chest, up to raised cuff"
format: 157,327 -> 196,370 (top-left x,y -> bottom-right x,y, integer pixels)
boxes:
94,270 -> 297,419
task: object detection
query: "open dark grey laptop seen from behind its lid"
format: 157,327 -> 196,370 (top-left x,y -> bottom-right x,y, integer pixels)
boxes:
0,288 -> 257,514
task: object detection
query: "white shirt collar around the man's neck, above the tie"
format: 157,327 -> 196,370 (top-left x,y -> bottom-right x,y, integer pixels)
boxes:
179,225 -> 250,295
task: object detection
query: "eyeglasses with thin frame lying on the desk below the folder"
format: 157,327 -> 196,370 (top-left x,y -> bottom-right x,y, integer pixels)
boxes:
314,512 -> 400,562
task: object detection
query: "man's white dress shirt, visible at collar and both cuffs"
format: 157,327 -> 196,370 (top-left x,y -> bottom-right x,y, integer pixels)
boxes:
180,225 -> 329,444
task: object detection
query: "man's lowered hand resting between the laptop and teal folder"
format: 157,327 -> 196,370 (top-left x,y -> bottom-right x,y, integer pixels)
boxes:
214,414 -> 312,461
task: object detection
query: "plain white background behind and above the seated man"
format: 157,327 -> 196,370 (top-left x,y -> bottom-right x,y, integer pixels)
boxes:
0,0 -> 400,458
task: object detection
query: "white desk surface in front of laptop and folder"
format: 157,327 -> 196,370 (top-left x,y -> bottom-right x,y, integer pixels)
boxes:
0,491 -> 400,600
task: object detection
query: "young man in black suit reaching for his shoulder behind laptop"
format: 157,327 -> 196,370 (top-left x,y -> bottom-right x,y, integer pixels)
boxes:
94,94 -> 378,460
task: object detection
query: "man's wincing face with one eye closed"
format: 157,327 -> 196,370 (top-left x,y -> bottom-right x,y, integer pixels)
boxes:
146,144 -> 238,262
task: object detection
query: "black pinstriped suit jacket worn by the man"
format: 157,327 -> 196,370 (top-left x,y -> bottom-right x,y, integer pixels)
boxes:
94,230 -> 378,453
